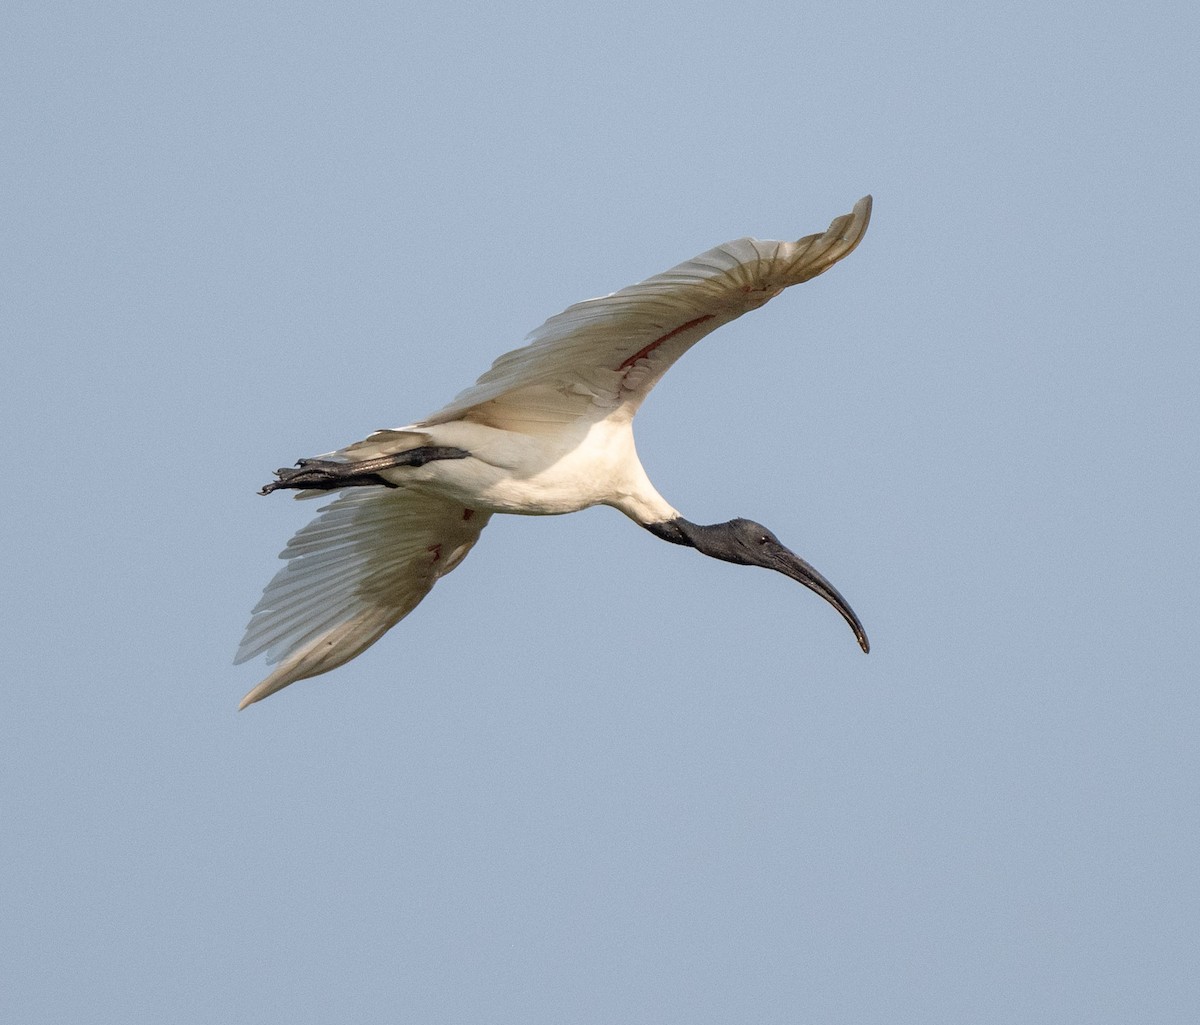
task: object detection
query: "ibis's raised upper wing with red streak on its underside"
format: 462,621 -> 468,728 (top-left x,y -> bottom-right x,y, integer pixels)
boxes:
415,196 -> 871,431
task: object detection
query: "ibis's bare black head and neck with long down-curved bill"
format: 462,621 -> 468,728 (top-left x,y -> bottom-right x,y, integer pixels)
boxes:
642,516 -> 871,652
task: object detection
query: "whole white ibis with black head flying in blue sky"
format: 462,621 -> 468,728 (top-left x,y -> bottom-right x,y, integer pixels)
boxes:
236,196 -> 871,708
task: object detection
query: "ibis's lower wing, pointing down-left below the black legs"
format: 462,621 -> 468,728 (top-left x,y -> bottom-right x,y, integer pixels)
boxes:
235,487 -> 491,708
